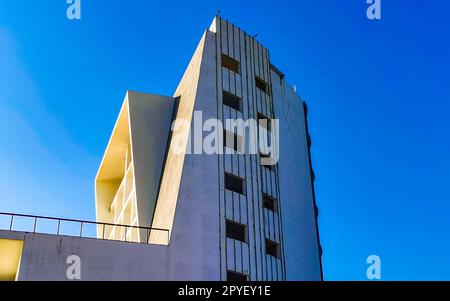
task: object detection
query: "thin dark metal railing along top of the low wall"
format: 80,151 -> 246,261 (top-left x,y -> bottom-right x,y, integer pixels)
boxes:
0,212 -> 170,245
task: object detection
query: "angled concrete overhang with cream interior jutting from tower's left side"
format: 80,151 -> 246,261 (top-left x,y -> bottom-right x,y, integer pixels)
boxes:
95,91 -> 174,244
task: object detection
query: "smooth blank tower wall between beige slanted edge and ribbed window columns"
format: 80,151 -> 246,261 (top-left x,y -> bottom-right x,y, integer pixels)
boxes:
164,31 -> 221,280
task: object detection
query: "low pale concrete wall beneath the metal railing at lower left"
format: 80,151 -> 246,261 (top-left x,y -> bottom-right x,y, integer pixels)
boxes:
0,231 -> 171,281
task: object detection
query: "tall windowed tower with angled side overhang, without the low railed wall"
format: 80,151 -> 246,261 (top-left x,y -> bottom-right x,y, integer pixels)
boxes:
97,17 -> 322,280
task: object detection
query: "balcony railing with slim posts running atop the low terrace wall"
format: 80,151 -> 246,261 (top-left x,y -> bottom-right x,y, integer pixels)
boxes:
0,212 -> 169,245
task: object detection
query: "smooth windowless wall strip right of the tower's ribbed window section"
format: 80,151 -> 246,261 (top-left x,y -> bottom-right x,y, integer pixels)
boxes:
272,72 -> 321,280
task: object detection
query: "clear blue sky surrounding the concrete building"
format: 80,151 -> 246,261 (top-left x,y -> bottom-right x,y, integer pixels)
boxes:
0,0 -> 450,280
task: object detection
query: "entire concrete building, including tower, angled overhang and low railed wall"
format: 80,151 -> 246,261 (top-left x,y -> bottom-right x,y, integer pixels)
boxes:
0,17 -> 322,281
